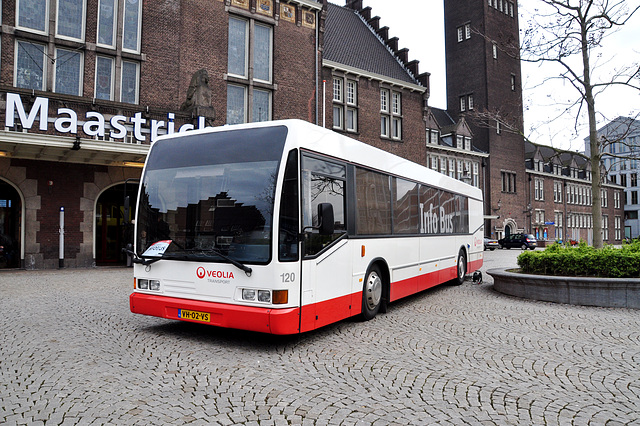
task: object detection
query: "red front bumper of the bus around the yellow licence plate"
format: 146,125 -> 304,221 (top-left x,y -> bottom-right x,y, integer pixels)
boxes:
129,292 -> 300,334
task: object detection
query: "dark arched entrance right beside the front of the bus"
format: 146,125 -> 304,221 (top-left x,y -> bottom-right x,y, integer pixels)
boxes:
95,183 -> 137,265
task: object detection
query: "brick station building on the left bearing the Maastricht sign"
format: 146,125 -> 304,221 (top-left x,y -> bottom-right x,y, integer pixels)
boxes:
0,0 -> 326,269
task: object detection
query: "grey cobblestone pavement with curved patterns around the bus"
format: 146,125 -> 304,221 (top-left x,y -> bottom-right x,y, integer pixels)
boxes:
0,250 -> 640,426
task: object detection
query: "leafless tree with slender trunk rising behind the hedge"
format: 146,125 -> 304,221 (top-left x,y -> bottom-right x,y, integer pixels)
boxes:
520,0 -> 640,248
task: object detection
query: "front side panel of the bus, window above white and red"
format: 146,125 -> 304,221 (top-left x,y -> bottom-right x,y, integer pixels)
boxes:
300,155 -> 352,332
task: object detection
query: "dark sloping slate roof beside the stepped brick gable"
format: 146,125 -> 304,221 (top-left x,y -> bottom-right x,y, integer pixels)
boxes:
323,3 -> 420,85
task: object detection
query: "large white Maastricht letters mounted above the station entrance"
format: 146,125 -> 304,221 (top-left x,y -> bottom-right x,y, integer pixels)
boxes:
5,93 -> 206,143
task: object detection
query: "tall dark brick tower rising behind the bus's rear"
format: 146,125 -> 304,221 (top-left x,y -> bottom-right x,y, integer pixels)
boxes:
444,0 -> 532,238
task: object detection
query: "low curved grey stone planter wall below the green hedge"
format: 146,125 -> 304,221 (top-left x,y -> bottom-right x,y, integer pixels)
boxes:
487,269 -> 640,309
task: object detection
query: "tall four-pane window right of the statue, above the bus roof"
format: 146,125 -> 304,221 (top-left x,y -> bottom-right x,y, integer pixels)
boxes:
227,16 -> 272,124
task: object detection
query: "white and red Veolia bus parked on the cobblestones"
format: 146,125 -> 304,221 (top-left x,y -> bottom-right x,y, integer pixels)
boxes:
130,120 -> 483,334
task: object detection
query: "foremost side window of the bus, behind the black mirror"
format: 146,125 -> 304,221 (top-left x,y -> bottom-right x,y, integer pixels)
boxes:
302,157 -> 347,256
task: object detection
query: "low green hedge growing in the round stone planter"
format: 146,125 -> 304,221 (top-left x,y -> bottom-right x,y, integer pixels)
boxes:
518,240 -> 640,278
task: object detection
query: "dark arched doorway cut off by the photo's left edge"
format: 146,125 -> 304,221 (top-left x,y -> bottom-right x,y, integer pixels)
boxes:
0,179 -> 22,268
